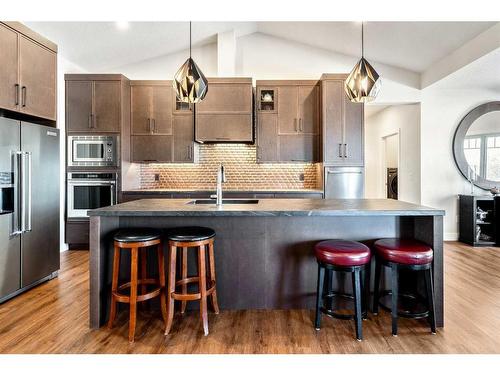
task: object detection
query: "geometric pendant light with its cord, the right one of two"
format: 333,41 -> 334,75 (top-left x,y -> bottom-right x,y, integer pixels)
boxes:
345,23 -> 380,103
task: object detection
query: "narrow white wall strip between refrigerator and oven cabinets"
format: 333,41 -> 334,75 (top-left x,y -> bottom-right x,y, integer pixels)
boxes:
57,54 -> 85,251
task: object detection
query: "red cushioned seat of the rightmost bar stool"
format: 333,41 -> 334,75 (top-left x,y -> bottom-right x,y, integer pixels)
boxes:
373,238 -> 434,265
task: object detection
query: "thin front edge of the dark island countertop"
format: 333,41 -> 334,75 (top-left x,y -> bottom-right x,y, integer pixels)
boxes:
88,208 -> 445,217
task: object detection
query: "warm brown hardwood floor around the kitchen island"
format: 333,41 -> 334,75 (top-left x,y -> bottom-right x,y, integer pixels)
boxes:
0,242 -> 500,353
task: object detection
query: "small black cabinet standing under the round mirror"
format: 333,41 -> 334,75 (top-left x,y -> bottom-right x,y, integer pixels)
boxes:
458,195 -> 500,246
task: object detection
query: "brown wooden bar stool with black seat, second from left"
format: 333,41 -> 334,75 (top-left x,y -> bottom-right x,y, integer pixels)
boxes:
165,227 -> 219,336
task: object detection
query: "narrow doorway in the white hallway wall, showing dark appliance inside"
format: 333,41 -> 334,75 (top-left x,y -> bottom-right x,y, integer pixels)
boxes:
381,132 -> 400,199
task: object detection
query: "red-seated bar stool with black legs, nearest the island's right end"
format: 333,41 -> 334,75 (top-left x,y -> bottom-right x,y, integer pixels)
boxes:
373,238 -> 436,336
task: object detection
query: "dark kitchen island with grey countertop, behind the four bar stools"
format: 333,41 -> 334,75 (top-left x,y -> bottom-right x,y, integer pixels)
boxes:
89,199 -> 444,328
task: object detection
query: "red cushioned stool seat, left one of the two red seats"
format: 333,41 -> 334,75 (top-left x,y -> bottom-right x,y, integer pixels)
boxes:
314,240 -> 371,267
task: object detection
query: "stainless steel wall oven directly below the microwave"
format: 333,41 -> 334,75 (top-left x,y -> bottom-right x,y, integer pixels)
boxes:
67,172 -> 118,219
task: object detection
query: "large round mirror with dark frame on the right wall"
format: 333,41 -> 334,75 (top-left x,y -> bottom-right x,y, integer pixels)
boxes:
453,102 -> 500,189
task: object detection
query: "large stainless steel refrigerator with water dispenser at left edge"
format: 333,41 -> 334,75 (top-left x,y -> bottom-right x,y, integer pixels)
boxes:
0,117 -> 59,302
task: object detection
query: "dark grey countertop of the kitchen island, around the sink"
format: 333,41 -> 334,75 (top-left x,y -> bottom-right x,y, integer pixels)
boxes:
88,199 -> 445,216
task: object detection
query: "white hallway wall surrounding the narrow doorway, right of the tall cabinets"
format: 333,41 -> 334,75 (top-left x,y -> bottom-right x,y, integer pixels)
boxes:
365,104 -> 421,204
